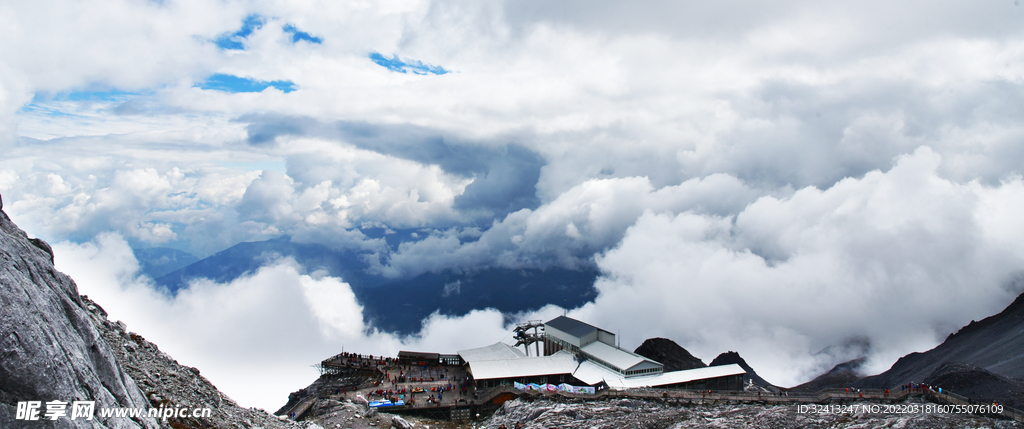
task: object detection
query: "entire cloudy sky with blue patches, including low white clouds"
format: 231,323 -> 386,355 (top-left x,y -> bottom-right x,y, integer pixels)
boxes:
0,0 -> 1024,412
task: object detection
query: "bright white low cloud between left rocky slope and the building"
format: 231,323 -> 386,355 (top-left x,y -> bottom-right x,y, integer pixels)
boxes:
54,234 -> 507,412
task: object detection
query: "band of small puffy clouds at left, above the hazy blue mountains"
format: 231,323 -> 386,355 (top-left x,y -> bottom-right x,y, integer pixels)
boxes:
0,139 -> 473,255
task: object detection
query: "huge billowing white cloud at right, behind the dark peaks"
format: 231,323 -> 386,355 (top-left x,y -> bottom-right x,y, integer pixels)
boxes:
577,147 -> 1024,385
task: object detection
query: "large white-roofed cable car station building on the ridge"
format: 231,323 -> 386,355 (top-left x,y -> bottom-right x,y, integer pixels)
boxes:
459,316 -> 745,390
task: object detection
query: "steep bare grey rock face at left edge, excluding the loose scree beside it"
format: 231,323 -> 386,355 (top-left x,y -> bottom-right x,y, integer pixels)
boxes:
0,207 -> 159,428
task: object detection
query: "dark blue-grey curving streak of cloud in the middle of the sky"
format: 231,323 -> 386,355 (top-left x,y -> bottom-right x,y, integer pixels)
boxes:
239,114 -> 545,219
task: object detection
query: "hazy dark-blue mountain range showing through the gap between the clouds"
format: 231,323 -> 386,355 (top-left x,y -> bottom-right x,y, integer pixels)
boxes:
156,237 -> 598,334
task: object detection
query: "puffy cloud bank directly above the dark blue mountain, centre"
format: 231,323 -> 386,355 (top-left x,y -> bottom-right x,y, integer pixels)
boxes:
380,174 -> 761,275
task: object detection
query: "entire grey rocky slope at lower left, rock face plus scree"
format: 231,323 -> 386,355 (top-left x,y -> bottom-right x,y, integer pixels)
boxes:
0,203 -> 305,429
